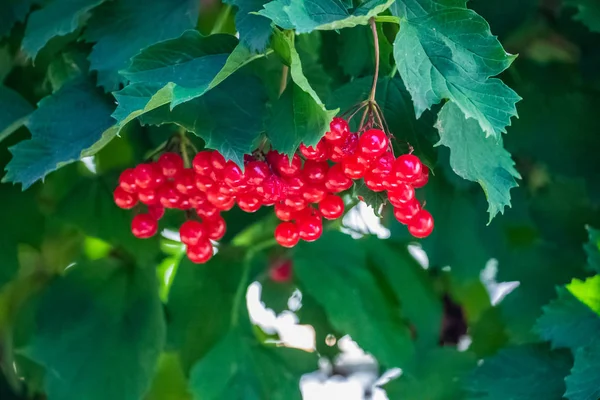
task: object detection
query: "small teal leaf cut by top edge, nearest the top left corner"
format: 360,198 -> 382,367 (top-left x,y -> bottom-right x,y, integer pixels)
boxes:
21,0 -> 104,59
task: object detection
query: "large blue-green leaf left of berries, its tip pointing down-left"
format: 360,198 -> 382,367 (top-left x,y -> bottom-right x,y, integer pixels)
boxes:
2,81 -> 114,189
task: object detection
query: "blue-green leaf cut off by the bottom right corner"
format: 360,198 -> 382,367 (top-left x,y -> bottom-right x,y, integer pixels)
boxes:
565,340 -> 600,400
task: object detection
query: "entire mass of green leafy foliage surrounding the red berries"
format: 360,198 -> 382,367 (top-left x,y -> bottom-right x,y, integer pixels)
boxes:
0,0 -> 600,400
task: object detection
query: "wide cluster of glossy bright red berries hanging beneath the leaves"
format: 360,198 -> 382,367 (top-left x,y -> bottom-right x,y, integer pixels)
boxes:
114,118 -> 433,263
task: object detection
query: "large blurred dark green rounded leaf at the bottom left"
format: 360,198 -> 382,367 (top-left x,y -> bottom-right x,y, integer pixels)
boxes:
25,259 -> 165,400
